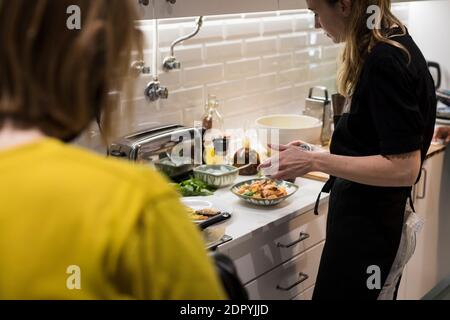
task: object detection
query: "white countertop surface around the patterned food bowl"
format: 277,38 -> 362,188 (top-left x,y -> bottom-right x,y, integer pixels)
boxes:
199,176 -> 328,250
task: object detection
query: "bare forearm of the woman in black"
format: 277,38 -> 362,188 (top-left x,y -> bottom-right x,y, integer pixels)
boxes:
313,151 -> 420,187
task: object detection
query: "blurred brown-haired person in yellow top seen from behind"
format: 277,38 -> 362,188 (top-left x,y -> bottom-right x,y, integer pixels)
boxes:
0,0 -> 226,299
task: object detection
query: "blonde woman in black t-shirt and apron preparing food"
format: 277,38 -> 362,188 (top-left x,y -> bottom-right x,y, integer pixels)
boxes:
262,0 -> 436,299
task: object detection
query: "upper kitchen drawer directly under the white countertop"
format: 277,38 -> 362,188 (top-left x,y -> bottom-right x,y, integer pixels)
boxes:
227,203 -> 328,284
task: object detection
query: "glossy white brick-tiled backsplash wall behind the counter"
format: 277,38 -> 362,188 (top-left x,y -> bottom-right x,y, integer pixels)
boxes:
76,5 -> 408,151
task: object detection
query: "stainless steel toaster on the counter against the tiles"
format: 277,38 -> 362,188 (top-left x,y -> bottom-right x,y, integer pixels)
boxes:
108,124 -> 202,181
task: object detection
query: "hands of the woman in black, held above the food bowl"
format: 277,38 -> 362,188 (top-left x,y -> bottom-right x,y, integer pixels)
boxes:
259,141 -> 314,180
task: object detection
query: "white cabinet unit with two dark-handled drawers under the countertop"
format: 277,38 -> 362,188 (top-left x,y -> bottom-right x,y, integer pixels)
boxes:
224,202 -> 328,300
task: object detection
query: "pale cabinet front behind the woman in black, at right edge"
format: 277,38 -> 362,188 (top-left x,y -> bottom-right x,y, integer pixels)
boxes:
398,153 -> 450,300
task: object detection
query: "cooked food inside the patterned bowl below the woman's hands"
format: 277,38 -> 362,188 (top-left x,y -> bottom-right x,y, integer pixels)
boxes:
237,179 -> 288,200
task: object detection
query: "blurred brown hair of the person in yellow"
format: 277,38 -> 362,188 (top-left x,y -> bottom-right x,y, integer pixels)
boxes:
0,0 -> 142,140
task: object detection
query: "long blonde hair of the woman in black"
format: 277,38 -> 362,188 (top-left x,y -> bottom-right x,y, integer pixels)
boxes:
327,0 -> 410,97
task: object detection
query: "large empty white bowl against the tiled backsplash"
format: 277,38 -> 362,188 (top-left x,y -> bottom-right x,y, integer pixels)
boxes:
256,114 -> 322,144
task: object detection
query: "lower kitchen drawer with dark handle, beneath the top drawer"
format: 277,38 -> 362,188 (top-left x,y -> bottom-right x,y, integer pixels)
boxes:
245,241 -> 325,300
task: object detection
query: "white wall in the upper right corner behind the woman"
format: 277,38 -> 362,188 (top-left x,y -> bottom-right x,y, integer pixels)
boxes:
408,0 -> 450,89
